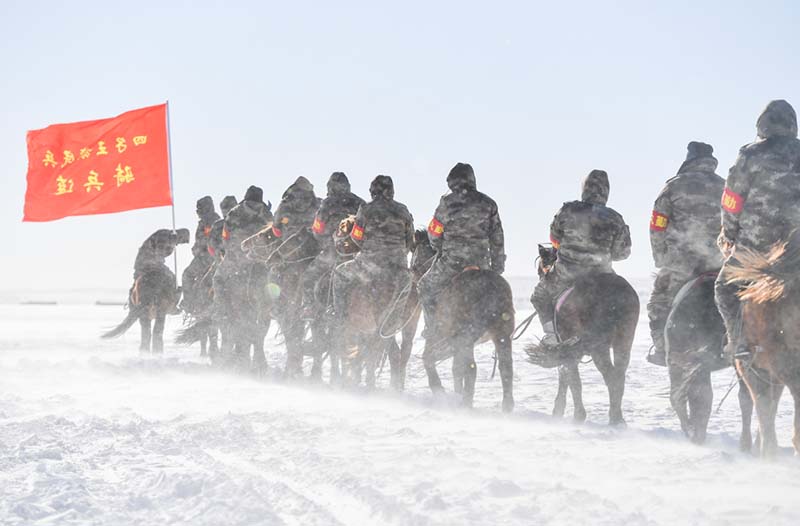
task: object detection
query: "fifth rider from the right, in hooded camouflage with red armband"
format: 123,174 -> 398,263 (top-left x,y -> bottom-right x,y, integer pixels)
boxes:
333,175 -> 414,325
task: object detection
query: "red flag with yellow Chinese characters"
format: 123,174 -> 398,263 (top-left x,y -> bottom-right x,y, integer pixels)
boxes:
22,104 -> 172,221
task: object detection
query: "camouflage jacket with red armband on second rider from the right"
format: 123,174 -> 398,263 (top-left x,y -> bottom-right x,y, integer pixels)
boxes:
650,156 -> 725,273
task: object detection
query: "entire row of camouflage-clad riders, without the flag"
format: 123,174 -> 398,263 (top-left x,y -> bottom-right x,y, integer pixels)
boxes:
114,100 -> 800,454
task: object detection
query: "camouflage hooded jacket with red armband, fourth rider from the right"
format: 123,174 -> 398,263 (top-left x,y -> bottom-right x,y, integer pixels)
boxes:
428,163 -> 506,273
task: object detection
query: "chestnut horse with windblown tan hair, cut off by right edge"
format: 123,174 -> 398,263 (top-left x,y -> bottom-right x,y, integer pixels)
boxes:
722,237 -> 800,458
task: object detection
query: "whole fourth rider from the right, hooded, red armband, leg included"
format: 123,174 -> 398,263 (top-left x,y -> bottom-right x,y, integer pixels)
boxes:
418,163 -> 506,338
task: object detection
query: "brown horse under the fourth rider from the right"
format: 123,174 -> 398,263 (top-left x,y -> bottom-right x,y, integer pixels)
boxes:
414,242 -> 514,412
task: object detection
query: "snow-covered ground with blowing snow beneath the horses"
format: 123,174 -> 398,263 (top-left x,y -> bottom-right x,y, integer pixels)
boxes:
0,296 -> 800,525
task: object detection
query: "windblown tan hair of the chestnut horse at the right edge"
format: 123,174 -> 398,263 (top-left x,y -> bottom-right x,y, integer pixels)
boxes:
723,233 -> 800,303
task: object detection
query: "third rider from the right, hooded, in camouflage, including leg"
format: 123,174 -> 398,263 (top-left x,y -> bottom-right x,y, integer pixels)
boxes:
531,170 -> 631,346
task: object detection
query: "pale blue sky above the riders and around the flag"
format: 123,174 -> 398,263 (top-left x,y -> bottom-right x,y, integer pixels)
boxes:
0,1 -> 800,290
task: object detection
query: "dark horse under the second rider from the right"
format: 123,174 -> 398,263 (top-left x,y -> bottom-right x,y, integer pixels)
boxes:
664,270 -> 753,451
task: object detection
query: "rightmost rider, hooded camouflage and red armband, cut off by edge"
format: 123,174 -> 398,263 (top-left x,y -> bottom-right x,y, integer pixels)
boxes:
715,100 -> 800,357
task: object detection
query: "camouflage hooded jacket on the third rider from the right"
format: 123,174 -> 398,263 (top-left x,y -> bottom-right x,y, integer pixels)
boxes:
550,170 -> 631,270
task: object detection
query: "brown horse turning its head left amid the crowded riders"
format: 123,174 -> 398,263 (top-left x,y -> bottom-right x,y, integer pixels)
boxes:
241,224 -> 322,378
